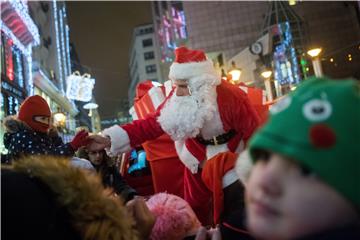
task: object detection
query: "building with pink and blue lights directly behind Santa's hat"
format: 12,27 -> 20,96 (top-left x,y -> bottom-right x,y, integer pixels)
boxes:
151,1 -> 188,83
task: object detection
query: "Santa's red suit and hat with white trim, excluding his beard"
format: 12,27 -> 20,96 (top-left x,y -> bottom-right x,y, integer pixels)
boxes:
103,47 -> 259,223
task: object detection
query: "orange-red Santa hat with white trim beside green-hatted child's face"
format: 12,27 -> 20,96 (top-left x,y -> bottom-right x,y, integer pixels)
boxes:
201,152 -> 238,224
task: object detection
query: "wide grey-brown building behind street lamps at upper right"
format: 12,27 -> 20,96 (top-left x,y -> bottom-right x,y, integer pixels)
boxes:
183,1 -> 360,95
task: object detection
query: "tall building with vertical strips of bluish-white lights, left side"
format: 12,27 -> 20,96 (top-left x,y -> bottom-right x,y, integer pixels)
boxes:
28,0 -> 78,141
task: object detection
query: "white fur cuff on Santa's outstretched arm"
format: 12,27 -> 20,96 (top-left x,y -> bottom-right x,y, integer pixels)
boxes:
102,125 -> 131,156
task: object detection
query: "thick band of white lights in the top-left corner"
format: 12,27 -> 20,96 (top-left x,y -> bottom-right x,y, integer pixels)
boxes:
5,0 -> 40,46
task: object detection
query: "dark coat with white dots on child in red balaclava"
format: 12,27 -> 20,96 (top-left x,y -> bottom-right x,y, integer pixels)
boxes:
4,117 -> 74,163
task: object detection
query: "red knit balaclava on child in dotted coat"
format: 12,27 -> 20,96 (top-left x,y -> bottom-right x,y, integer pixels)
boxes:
18,95 -> 51,132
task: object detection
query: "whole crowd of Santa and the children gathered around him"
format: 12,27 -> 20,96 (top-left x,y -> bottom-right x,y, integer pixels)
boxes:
1,47 -> 360,240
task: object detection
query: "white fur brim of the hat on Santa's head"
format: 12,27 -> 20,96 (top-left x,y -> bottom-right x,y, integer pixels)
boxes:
169,59 -> 221,86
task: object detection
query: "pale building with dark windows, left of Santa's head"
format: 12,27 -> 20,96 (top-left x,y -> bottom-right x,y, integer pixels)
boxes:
128,24 -> 160,105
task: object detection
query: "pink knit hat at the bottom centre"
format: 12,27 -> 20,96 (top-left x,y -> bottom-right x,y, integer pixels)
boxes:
146,193 -> 201,240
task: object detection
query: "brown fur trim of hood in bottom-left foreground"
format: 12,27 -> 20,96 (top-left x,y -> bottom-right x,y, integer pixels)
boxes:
4,156 -> 138,240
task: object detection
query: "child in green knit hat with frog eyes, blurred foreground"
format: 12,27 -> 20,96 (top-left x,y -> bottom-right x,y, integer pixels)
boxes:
246,78 -> 360,239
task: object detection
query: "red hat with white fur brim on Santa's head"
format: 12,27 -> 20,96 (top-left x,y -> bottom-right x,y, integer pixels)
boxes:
169,46 -> 221,87
